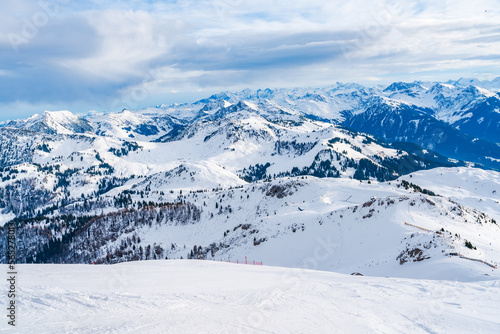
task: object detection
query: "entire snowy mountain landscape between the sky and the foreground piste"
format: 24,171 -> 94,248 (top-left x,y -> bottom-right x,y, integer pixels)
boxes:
0,82 -> 500,279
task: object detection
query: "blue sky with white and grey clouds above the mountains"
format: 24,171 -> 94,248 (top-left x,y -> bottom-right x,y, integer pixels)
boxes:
0,0 -> 500,121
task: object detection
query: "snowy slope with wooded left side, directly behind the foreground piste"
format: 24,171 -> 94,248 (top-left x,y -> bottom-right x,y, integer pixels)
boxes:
6,175 -> 500,281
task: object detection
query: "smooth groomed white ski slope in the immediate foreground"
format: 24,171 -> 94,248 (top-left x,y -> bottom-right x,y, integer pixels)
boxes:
9,260 -> 500,334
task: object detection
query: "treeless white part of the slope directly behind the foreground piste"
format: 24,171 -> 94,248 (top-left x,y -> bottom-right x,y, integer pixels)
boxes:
112,178 -> 500,280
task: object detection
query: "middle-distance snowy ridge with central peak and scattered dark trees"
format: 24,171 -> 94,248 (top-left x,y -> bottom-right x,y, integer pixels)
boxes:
0,105 -> 460,220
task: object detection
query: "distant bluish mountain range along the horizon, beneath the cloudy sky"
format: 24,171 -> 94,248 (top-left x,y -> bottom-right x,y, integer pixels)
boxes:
4,78 -> 500,169
